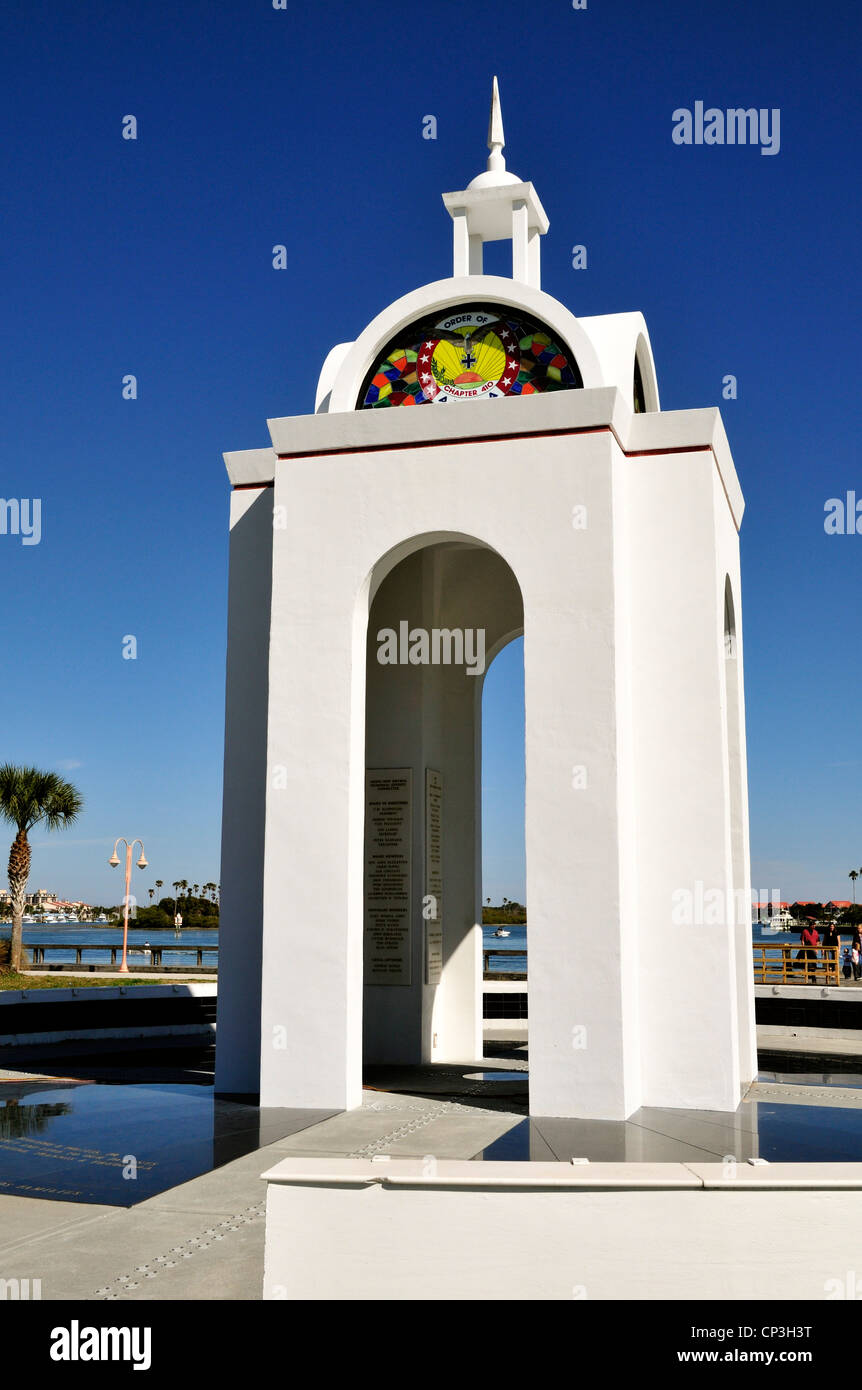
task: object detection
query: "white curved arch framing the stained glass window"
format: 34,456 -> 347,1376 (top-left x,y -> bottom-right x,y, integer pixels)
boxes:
325,275 -> 612,413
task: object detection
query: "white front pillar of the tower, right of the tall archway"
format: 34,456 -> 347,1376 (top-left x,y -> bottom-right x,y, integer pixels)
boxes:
516,435 -> 641,1119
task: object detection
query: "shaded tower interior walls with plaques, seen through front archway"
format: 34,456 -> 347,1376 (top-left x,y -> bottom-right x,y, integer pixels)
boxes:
363,534 -> 523,1065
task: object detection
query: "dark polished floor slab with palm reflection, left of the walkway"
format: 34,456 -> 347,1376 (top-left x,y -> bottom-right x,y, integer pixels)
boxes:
0,1081 -> 330,1207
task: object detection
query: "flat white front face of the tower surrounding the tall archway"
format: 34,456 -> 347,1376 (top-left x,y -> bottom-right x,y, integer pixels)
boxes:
261,411 -> 640,1118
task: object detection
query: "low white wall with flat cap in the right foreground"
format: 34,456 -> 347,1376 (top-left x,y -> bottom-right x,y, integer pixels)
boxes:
263,1158 -> 862,1302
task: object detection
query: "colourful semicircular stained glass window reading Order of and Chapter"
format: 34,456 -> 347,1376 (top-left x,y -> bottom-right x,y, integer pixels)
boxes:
357,304 -> 584,410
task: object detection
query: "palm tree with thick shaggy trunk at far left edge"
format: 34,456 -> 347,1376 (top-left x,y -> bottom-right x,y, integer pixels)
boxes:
0,763 -> 83,970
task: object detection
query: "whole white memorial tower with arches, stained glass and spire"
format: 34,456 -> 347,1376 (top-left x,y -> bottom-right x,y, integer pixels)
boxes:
217,81 -> 756,1119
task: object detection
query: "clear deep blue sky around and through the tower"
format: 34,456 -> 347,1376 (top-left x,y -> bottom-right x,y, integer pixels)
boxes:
0,0 -> 862,901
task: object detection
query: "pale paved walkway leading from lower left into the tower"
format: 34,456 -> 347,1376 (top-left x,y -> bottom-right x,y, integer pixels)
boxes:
0,1062 -> 526,1301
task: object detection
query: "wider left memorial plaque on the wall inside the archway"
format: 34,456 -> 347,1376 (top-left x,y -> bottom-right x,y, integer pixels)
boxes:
364,767 -> 413,984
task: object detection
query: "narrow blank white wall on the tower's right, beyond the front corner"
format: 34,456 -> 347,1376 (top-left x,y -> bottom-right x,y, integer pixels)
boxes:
628,452 -> 742,1109
